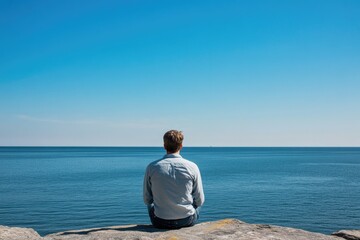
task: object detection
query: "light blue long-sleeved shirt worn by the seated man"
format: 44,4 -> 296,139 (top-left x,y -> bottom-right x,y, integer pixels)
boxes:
143,154 -> 205,220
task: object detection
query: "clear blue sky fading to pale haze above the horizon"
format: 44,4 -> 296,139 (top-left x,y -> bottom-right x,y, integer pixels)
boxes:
0,0 -> 360,146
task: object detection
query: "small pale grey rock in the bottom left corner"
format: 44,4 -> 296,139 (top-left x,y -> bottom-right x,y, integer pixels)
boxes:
0,226 -> 42,240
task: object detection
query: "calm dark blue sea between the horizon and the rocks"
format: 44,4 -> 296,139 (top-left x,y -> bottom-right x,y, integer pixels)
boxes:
0,147 -> 360,235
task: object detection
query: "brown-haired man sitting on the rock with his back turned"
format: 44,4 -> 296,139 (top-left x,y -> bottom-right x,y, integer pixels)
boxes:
144,130 -> 205,229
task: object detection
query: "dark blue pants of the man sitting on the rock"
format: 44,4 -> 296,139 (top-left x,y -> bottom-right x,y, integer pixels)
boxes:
148,206 -> 199,229
